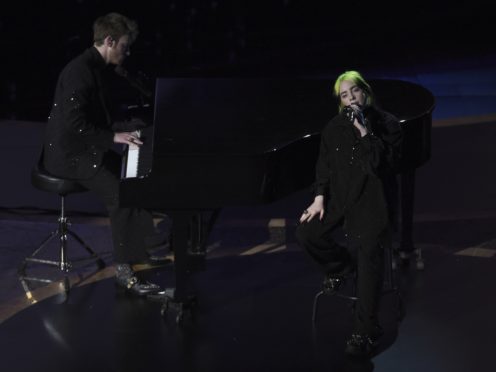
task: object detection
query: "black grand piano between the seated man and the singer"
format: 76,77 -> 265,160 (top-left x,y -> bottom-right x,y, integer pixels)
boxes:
120,78 -> 434,319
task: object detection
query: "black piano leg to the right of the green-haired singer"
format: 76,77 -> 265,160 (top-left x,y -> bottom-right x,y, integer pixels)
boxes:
399,170 -> 424,270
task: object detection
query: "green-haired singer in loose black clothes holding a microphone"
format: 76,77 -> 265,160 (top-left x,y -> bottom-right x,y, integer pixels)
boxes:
296,71 -> 402,357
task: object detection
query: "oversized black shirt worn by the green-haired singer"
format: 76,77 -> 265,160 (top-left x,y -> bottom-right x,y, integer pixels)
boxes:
315,107 -> 403,242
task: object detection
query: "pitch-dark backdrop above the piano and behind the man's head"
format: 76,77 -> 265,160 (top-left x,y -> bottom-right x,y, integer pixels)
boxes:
0,0 -> 496,121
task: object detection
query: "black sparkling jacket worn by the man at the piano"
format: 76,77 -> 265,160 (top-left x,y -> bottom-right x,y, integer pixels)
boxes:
44,47 -> 114,179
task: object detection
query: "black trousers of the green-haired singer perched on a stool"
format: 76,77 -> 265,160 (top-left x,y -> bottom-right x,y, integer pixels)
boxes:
296,215 -> 389,333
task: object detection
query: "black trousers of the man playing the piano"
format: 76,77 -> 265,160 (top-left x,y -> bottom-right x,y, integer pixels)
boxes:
78,151 -> 155,264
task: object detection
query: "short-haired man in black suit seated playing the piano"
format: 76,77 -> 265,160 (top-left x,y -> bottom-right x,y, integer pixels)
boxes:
44,13 -> 160,295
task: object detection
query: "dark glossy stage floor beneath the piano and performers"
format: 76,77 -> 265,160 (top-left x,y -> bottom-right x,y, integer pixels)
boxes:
0,211 -> 496,372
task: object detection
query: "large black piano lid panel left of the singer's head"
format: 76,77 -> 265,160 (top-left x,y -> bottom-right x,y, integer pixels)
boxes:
153,78 -> 337,156
